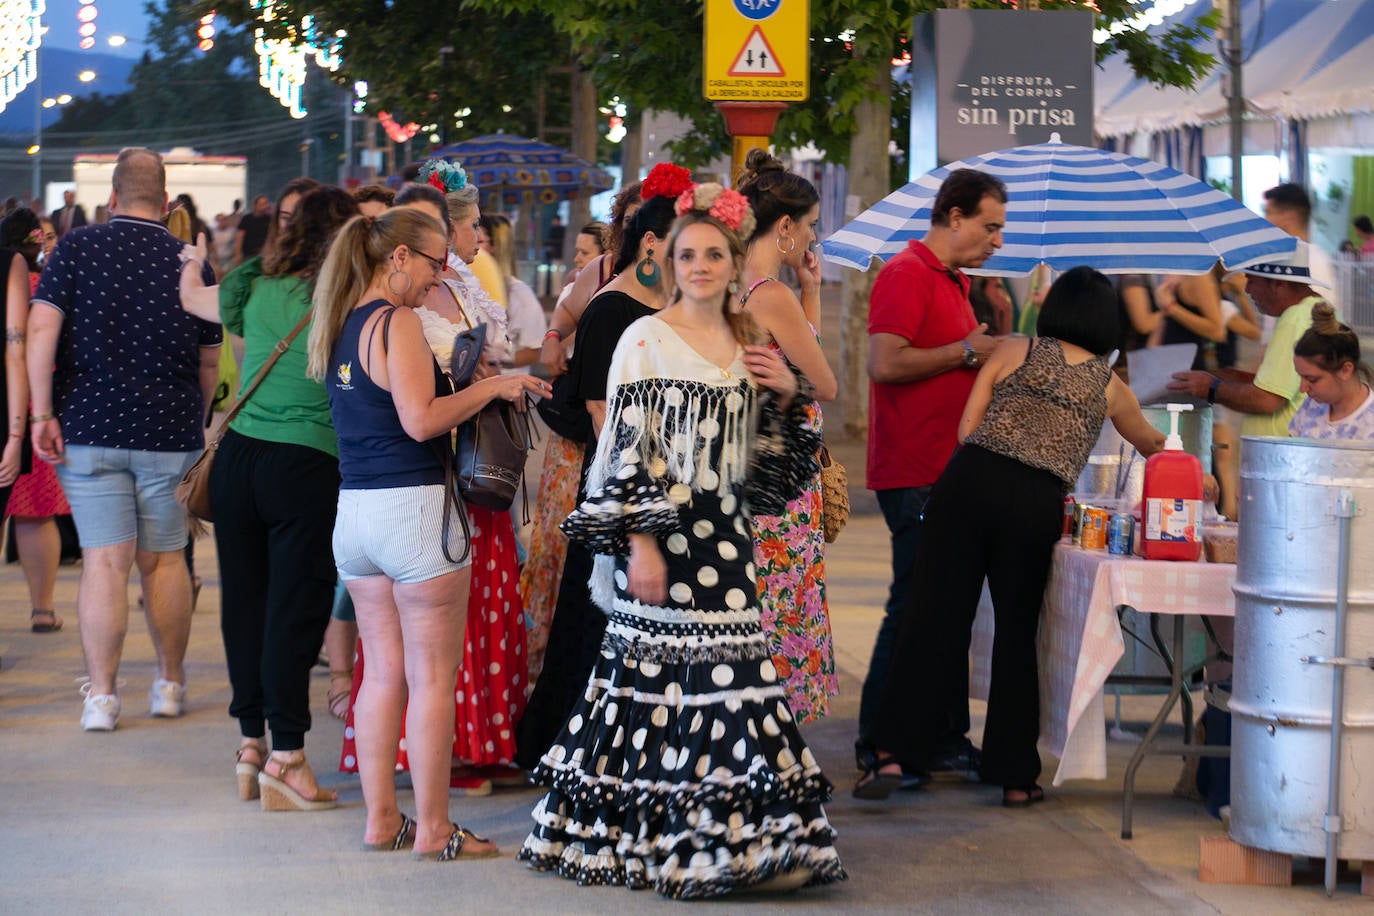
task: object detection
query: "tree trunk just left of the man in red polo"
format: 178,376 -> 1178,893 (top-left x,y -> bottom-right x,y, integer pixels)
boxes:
840,53 -> 892,438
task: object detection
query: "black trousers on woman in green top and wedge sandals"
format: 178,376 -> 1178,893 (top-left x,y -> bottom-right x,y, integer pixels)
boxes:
210,430 -> 339,751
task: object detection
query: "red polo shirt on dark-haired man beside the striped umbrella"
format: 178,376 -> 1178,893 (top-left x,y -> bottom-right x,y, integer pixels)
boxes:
868,240 -> 978,490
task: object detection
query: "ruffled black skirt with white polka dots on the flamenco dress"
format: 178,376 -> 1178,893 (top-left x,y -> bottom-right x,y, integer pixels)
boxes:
518,494 -> 845,898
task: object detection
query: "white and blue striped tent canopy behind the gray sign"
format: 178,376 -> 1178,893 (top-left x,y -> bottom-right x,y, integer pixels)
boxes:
1094,0 -> 1374,146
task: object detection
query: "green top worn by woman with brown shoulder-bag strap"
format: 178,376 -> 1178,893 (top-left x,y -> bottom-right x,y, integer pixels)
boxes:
220,258 -> 339,457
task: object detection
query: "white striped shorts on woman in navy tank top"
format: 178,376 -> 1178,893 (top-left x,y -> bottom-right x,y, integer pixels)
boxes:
334,485 -> 469,585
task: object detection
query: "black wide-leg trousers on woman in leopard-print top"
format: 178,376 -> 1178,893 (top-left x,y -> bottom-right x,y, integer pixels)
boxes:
871,446 -> 1063,787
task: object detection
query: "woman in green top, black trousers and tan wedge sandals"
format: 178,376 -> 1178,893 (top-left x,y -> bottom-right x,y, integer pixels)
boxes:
183,187 -> 357,810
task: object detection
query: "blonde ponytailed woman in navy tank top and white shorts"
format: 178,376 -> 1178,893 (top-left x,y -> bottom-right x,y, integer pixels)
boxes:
308,207 -> 548,861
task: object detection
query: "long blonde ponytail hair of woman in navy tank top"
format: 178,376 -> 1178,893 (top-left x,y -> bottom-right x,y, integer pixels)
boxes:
305,207 -> 445,382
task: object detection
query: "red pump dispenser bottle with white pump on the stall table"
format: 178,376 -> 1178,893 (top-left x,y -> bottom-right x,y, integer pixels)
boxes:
1140,404 -> 1202,560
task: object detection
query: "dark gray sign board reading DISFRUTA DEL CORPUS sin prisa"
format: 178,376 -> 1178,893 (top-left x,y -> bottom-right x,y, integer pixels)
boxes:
910,10 -> 1094,179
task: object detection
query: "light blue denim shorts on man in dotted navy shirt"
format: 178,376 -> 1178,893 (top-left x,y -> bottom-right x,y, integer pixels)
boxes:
55,445 -> 199,553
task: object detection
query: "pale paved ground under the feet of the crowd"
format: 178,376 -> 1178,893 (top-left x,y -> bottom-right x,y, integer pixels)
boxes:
0,515 -> 1370,916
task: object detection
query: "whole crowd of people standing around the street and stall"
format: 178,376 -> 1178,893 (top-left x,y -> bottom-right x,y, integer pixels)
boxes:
0,148 -> 1374,898
